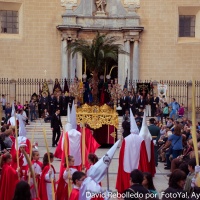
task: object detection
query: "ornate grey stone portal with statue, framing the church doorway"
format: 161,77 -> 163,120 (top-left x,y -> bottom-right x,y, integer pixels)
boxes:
57,0 -> 144,85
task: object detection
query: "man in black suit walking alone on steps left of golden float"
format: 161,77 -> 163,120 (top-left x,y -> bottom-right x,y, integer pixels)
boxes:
51,109 -> 63,147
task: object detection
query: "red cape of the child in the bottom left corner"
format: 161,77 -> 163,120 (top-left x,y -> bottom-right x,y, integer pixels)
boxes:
0,163 -> 19,200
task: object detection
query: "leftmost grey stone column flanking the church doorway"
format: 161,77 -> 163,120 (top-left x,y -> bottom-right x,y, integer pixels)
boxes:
61,38 -> 68,78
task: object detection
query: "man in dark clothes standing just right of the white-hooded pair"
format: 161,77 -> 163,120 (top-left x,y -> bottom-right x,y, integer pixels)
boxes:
148,118 -> 160,167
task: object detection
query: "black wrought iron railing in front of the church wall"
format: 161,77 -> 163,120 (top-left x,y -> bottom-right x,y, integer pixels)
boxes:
0,78 -> 200,112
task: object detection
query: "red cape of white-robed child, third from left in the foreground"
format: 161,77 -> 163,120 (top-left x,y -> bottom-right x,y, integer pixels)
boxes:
39,165 -> 56,200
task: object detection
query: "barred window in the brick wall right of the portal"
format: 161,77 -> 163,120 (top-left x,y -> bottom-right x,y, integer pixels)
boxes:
179,15 -> 196,37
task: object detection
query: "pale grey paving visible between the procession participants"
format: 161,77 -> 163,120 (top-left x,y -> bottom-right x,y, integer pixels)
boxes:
27,117 -> 169,199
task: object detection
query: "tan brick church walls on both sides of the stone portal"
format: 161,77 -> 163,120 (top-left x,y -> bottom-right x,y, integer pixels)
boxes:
0,0 -> 200,80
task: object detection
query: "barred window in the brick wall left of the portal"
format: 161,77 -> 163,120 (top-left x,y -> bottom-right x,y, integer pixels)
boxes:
0,10 -> 19,34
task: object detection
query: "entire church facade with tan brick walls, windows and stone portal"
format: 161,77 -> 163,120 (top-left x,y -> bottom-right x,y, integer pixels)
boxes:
0,0 -> 200,85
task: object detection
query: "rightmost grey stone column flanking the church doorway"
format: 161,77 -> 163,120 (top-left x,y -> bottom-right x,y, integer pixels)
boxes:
133,40 -> 139,80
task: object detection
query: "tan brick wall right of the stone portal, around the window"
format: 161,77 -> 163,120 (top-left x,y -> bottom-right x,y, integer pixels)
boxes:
138,0 -> 200,80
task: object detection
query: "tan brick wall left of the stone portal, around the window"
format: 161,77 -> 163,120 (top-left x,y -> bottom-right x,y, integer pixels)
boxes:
0,0 -> 64,79
